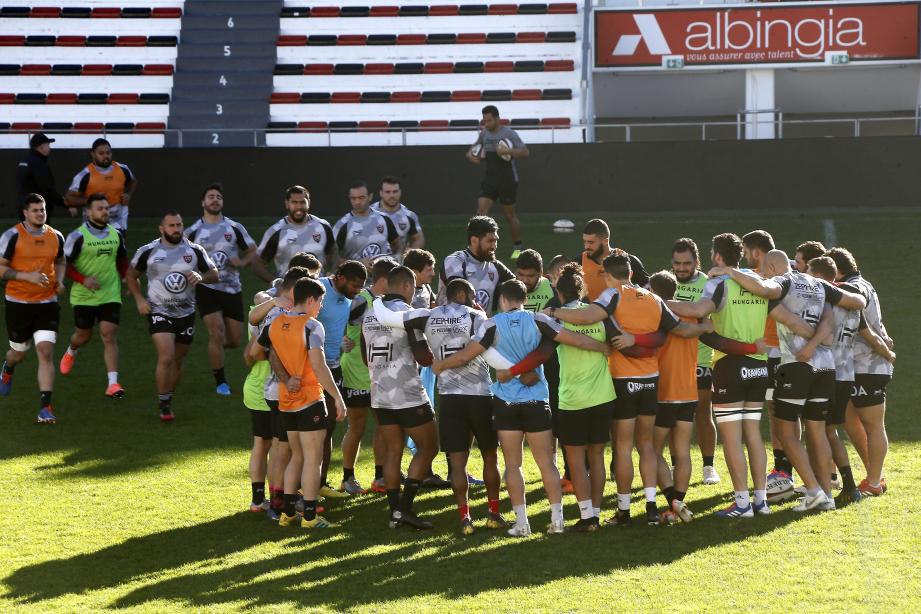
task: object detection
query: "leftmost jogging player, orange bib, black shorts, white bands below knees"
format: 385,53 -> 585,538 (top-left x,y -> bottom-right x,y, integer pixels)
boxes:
0,194 -> 66,424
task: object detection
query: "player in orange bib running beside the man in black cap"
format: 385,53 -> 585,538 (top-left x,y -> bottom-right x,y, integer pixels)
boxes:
64,139 -> 138,232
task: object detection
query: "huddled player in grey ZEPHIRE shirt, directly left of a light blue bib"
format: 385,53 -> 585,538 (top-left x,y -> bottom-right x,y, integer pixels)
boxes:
374,279 -> 507,535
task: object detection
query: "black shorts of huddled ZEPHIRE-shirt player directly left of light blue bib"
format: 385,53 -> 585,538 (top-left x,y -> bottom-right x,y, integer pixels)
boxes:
438,394 -> 499,452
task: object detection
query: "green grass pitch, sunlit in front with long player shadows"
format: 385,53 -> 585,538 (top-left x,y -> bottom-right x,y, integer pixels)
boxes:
0,207 -> 921,612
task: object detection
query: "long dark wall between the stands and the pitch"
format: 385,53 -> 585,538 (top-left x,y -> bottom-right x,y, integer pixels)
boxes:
0,134 -> 921,217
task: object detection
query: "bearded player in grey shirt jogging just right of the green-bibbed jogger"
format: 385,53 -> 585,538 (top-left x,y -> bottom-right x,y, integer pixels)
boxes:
125,210 -> 218,422
